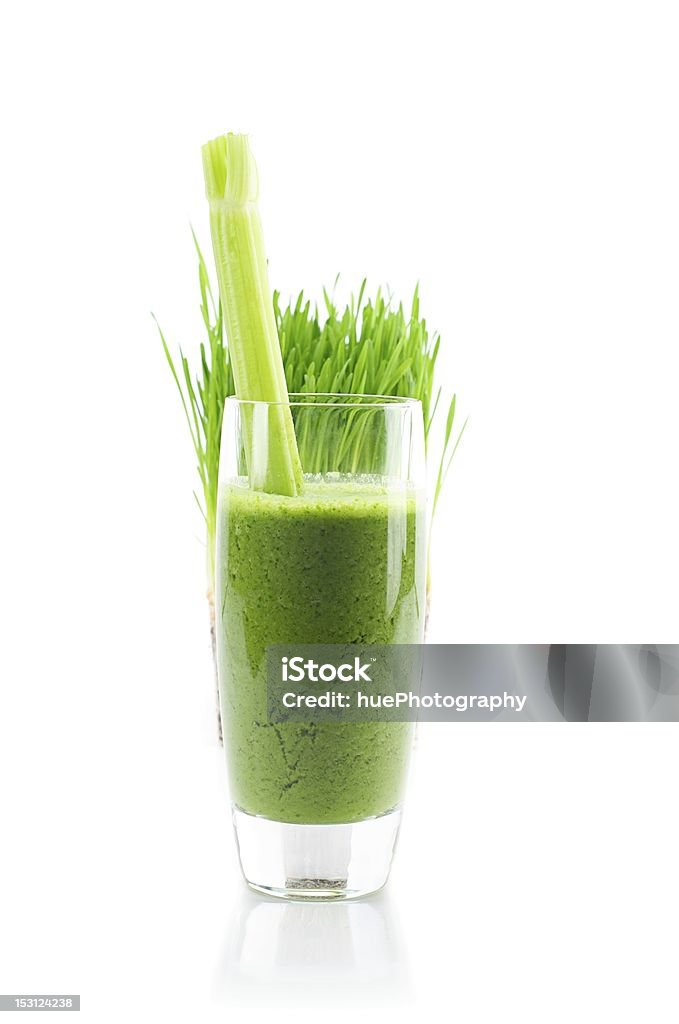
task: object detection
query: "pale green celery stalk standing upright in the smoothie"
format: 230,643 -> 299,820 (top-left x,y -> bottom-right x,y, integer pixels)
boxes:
203,133 -> 302,495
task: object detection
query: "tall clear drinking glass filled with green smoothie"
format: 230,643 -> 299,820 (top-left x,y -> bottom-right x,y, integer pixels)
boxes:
216,394 -> 426,899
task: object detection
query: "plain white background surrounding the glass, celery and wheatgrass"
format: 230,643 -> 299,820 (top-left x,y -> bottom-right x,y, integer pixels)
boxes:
0,0 -> 679,1024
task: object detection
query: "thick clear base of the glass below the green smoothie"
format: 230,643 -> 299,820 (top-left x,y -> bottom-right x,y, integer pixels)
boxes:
234,807 -> 400,900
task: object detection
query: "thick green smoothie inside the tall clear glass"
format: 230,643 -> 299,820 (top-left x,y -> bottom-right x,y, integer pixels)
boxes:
217,478 -> 425,824
